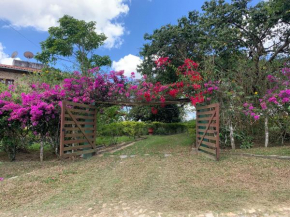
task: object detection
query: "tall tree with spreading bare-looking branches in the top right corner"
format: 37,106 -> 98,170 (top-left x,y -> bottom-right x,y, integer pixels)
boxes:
201,0 -> 290,88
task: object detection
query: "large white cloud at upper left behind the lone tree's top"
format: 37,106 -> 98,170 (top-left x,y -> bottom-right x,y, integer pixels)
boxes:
0,0 -> 129,48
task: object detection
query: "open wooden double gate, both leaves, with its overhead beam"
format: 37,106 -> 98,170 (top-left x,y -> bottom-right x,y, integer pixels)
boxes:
60,98 -> 220,160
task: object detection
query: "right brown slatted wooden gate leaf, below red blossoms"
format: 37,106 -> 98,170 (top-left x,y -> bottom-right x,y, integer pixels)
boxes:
196,103 -> 220,160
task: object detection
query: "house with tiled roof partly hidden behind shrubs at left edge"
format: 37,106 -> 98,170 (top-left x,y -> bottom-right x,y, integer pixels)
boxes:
0,60 -> 43,85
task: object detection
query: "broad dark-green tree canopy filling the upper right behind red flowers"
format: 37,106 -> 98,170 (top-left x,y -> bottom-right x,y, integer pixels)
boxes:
139,0 -> 290,82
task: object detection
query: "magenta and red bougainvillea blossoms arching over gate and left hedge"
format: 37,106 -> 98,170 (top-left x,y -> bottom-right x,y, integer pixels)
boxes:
0,57 -> 211,133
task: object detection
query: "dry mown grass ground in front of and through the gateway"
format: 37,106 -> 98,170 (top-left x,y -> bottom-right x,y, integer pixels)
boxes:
0,134 -> 290,217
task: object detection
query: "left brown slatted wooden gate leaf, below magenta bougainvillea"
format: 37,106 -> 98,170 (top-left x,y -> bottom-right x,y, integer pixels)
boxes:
60,101 -> 97,158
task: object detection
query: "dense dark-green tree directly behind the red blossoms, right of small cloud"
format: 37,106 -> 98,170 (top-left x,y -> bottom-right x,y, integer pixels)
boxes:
138,11 -> 204,83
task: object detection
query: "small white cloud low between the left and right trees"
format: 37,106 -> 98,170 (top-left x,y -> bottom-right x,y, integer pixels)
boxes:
112,54 -> 142,79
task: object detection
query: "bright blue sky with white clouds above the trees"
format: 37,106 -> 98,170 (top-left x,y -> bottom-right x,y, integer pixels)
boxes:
0,0 -> 258,73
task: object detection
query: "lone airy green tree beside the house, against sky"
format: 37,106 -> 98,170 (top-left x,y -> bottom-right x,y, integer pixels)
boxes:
35,15 -> 111,74
